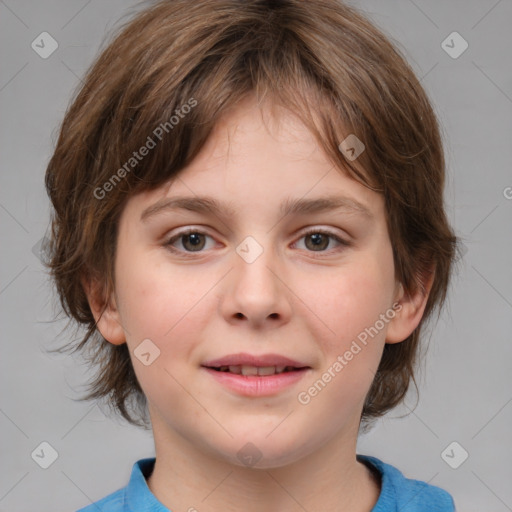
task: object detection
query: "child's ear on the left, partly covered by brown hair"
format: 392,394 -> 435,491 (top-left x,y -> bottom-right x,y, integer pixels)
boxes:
81,277 -> 126,345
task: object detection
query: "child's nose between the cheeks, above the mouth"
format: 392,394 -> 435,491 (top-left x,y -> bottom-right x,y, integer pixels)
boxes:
220,240 -> 293,328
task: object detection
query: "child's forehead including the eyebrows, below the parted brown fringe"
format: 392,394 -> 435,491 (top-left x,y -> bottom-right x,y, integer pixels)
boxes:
126,100 -> 383,222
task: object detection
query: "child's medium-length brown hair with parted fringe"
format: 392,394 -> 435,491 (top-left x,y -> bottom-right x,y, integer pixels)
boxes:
46,0 -> 457,426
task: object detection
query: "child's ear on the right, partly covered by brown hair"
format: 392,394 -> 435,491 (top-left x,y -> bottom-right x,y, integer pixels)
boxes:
386,270 -> 435,343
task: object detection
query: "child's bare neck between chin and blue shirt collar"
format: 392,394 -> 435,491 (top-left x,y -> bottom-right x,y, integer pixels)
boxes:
147,414 -> 380,512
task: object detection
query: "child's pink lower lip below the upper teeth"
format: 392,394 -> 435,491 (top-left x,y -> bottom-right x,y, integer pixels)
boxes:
203,366 -> 309,396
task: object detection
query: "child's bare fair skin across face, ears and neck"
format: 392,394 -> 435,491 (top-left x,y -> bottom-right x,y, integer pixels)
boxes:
87,96 -> 430,512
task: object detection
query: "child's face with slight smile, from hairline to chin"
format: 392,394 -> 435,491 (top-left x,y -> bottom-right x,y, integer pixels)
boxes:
99,96 -> 414,467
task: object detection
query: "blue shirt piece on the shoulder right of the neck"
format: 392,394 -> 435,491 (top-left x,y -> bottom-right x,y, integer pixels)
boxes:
357,455 -> 455,512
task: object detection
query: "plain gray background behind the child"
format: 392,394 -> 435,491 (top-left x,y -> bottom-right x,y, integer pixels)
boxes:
0,0 -> 512,512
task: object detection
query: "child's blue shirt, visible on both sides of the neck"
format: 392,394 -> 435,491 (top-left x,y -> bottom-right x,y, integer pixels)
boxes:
77,455 -> 455,512
